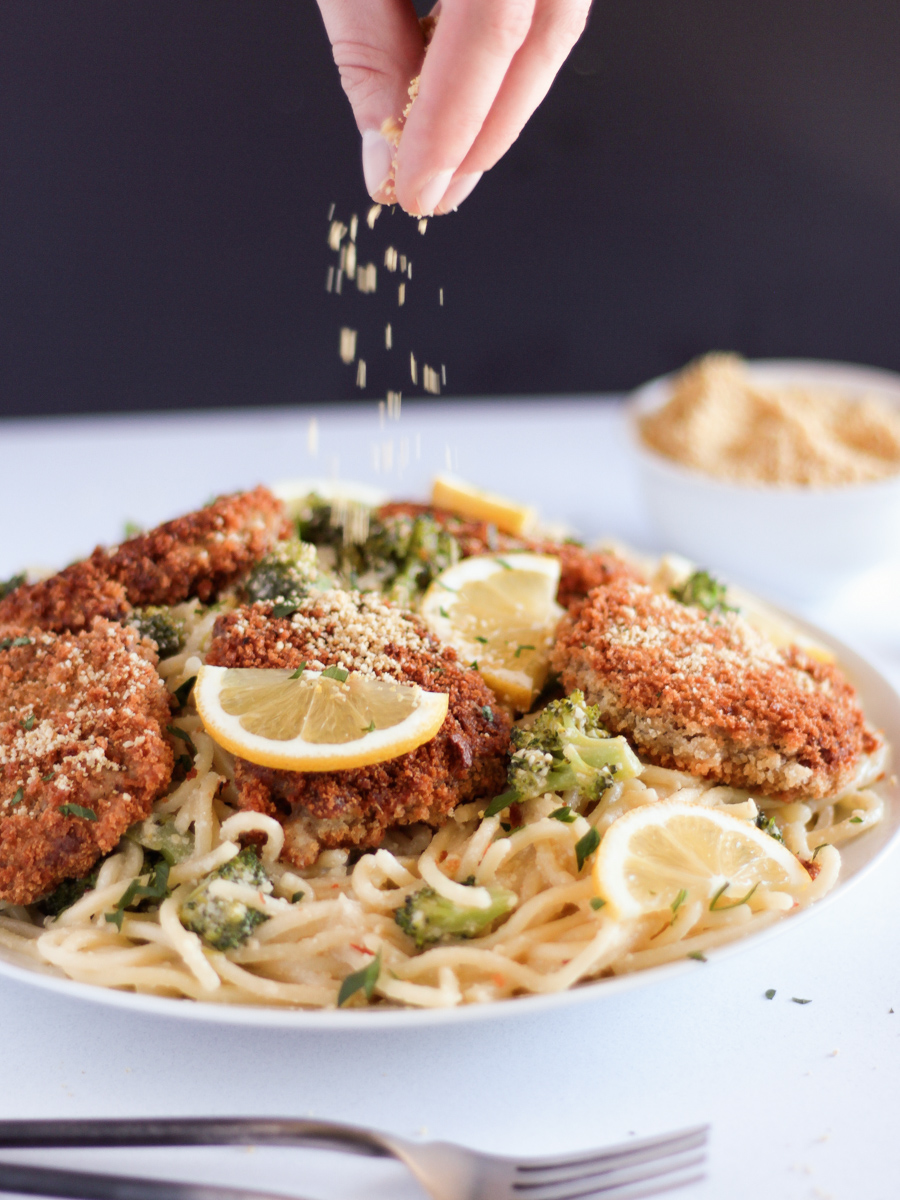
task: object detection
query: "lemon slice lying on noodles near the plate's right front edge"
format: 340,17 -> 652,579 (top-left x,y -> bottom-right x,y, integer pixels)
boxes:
594,800 -> 810,917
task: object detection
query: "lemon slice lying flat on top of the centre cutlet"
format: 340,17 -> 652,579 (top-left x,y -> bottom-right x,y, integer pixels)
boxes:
193,666 -> 448,770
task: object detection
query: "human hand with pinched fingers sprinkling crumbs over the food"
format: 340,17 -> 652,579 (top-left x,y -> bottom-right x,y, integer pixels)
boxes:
318,0 -> 590,216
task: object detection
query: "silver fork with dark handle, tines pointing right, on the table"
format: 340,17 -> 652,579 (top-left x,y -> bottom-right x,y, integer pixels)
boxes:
0,1117 -> 709,1200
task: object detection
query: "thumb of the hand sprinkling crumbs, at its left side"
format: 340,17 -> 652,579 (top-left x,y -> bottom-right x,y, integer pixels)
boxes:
318,0 -> 425,200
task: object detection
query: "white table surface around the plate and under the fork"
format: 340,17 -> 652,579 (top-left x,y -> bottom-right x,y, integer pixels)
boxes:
0,400 -> 900,1200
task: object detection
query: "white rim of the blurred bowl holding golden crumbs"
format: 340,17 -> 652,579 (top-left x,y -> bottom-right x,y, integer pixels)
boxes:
625,359 -> 900,503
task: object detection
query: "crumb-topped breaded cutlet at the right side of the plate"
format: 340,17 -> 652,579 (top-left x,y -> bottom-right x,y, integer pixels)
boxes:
552,580 -> 880,800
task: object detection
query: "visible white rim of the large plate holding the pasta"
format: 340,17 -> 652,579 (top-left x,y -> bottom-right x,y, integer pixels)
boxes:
0,616 -> 900,1032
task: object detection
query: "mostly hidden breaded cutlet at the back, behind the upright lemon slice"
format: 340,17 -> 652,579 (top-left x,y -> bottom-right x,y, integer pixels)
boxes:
377,500 -> 646,608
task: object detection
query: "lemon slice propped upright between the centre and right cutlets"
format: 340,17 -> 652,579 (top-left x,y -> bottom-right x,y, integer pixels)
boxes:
421,553 -> 563,713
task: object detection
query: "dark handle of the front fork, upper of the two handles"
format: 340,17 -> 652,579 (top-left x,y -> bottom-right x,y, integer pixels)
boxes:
0,1117 -> 391,1158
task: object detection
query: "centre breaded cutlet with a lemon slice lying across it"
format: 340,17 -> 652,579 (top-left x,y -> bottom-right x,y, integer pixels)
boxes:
206,592 -> 510,868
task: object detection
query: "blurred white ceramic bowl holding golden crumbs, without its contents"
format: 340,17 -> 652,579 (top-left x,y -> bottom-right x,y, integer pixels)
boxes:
628,359 -> 900,602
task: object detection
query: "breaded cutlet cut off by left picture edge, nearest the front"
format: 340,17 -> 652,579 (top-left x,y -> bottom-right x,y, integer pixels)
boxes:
0,618 -> 173,904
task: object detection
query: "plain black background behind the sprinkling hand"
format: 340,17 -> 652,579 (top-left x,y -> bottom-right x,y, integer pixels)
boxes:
0,0 -> 900,415
